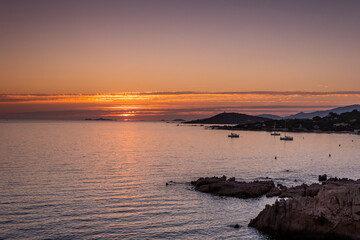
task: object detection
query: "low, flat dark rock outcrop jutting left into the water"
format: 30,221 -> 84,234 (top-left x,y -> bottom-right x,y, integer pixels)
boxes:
191,176 -> 275,198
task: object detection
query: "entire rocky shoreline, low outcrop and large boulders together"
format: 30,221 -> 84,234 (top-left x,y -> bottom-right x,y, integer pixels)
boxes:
191,175 -> 360,239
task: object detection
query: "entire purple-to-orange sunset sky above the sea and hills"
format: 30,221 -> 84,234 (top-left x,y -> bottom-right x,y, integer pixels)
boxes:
0,0 -> 360,120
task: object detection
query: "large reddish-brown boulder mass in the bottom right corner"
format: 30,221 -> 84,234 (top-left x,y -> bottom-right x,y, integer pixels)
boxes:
249,178 -> 360,239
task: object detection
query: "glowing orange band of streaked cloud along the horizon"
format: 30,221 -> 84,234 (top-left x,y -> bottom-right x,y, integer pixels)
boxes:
0,92 -> 360,121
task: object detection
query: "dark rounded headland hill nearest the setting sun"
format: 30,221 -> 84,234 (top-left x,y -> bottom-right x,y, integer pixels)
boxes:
185,112 -> 269,124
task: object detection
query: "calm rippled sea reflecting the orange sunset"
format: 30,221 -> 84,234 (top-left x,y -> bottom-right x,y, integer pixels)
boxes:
0,121 -> 360,239
